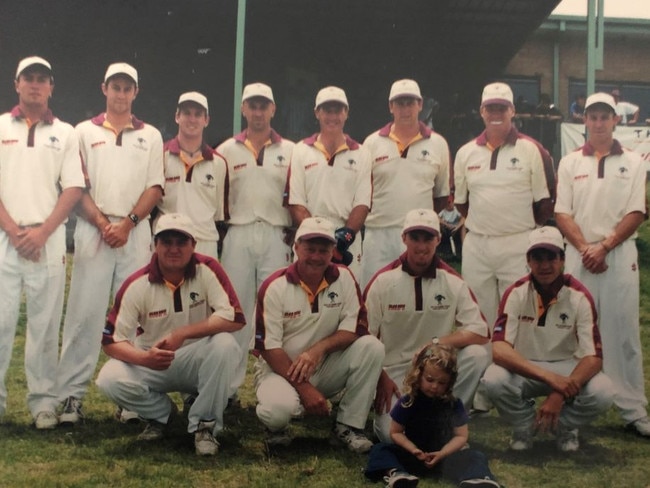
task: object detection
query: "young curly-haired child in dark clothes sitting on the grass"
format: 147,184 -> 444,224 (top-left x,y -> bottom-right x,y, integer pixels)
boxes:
365,344 -> 499,488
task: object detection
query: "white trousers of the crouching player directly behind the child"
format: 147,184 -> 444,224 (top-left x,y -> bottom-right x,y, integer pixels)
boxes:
373,344 -> 492,444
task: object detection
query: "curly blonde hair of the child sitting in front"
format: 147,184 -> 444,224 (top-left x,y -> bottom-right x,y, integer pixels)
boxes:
402,344 -> 458,407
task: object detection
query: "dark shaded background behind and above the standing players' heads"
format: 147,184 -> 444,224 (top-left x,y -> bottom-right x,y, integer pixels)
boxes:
0,0 -> 559,144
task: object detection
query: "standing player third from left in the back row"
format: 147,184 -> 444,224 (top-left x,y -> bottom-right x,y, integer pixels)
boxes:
158,92 -> 228,259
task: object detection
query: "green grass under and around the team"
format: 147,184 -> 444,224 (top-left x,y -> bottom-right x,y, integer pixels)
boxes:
0,231 -> 650,488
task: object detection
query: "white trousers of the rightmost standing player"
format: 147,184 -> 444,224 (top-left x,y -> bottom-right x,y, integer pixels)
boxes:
565,239 -> 648,422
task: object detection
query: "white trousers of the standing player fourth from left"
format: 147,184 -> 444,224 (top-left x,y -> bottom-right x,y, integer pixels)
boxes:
221,221 -> 291,385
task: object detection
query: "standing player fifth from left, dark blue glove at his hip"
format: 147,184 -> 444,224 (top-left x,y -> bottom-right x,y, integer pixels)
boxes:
286,86 -> 372,277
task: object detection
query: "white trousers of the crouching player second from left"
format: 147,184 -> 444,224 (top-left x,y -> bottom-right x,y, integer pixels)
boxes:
255,335 -> 384,432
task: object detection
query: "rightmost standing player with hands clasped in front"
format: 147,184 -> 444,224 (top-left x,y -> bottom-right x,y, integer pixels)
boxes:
555,93 -> 650,438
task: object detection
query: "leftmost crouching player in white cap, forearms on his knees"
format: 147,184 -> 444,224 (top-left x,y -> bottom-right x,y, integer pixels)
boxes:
97,214 -> 244,456
